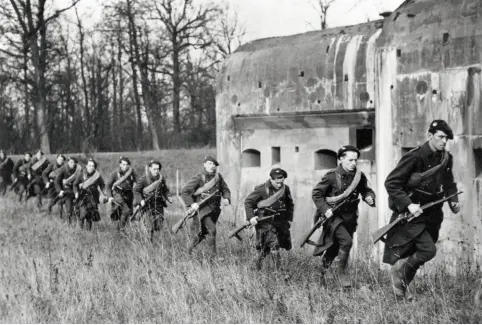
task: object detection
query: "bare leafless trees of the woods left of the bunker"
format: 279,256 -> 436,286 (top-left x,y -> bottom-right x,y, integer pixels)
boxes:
0,0 -> 244,153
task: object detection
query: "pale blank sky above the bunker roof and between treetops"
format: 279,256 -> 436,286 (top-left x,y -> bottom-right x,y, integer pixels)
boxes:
69,0 -> 403,42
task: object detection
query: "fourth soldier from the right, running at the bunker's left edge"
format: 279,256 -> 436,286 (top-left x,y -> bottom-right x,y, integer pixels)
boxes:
181,156 -> 231,256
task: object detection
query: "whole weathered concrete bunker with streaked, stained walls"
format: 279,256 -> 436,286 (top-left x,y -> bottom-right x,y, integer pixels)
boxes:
216,0 -> 482,270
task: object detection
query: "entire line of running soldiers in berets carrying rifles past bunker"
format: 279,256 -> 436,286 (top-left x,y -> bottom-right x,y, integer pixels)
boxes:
0,120 -> 460,298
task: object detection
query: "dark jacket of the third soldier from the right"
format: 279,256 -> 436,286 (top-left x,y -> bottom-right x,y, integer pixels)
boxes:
244,180 -> 295,224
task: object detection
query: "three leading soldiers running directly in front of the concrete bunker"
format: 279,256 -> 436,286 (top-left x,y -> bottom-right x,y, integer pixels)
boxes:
241,120 -> 460,299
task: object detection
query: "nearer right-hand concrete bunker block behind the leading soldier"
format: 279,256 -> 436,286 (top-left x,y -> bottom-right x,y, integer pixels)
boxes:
375,0 -> 482,271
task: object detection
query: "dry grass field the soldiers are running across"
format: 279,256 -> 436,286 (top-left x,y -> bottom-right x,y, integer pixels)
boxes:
0,149 -> 482,323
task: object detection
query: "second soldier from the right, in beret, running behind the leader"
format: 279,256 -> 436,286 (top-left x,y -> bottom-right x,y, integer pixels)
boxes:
312,146 -> 375,287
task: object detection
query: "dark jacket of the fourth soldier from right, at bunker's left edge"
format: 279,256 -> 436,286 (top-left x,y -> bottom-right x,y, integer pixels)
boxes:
181,170 -> 231,215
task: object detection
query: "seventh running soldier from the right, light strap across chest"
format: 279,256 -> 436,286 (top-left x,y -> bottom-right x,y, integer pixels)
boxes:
73,158 -> 105,230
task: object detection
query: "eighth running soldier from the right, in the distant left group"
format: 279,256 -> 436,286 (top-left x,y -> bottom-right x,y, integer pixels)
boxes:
55,157 -> 82,218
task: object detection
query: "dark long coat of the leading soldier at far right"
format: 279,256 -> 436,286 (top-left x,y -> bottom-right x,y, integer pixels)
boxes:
385,142 -> 458,248
